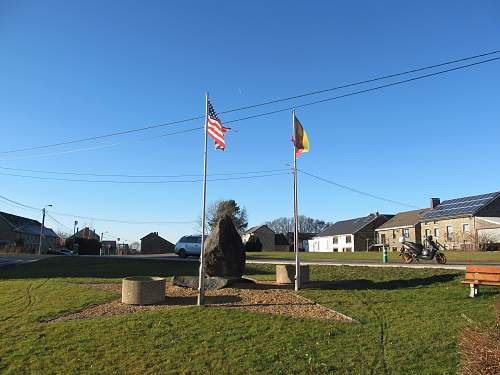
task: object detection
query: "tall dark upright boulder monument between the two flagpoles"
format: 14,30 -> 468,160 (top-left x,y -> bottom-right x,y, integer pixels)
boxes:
204,216 -> 246,279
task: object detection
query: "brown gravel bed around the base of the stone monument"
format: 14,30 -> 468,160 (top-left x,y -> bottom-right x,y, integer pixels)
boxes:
51,282 -> 355,322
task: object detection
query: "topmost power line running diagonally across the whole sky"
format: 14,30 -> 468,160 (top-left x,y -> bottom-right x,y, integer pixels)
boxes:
0,50 -> 500,154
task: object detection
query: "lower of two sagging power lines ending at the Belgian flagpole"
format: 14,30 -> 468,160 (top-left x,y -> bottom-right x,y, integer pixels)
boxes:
0,172 -> 290,185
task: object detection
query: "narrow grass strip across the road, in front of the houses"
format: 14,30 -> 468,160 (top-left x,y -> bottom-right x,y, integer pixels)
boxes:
247,251 -> 500,263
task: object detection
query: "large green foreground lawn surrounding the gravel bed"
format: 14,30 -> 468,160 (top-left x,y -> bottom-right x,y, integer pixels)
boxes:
0,257 -> 500,375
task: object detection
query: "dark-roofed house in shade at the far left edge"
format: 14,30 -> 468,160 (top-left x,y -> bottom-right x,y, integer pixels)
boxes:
0,212 -> 59,254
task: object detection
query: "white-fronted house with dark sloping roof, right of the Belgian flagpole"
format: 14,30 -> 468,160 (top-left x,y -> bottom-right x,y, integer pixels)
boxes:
308,212 -> 394,252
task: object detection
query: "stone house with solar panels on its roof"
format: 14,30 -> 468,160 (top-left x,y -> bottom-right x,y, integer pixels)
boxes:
421,192 -> 500,250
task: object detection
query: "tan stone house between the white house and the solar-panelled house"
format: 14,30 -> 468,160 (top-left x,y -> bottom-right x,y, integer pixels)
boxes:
375,208 -> 430,251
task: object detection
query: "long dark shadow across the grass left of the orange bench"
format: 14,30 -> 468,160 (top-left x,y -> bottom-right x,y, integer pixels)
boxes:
303,273 -> 466,290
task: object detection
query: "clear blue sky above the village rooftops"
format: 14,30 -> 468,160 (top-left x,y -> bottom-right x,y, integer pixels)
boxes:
0,1 -> 500,241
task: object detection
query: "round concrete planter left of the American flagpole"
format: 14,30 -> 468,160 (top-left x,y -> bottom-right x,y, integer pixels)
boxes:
122,276 -> 166,305
